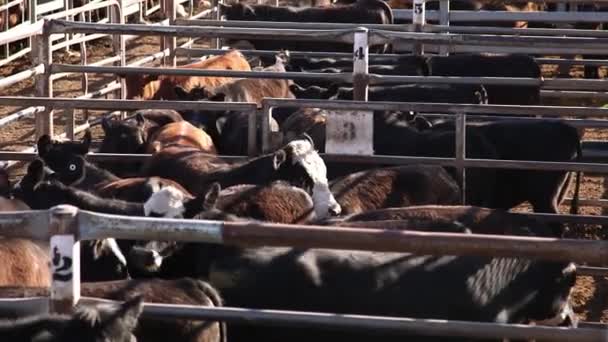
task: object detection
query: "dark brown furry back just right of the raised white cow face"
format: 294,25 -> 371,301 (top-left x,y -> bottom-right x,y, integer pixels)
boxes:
330,165 -> 460,215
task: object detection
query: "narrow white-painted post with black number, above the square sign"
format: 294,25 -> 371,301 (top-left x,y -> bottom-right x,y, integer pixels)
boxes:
353,27 -> 369,101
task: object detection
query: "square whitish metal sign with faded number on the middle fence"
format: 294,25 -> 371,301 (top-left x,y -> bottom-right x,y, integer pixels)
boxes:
325,111 -> 374,155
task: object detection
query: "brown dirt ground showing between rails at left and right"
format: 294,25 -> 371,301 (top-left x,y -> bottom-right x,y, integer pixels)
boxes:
0,4 -> 608,323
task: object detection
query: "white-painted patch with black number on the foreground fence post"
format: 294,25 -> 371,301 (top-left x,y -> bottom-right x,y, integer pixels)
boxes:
50,235 -> 80,305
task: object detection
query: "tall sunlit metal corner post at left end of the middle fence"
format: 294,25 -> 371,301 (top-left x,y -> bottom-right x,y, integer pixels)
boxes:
32,24 -> 53,139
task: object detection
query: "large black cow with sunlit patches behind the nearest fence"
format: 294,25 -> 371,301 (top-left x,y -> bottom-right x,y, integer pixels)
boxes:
156,232 -> 576,341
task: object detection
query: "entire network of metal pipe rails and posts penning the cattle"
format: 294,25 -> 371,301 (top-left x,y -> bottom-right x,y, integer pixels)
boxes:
0,1 -> 608,341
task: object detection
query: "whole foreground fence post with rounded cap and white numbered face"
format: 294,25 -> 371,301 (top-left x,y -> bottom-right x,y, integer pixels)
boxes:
49,205 -> 80,314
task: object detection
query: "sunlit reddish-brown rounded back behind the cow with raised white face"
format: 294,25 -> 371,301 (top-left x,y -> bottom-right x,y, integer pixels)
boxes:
146,121 -> 217,154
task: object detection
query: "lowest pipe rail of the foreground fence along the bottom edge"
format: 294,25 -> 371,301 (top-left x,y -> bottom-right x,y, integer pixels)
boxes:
137,304 -> 606,342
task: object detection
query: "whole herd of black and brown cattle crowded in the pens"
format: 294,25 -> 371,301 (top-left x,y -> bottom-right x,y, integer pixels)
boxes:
0,0 -> 608,342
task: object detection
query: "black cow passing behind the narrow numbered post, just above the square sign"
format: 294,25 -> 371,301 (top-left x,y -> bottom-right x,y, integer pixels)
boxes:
290,84 -> 488,104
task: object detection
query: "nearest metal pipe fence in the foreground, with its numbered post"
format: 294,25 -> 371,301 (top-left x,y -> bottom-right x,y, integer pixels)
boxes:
0,206 -> 608,341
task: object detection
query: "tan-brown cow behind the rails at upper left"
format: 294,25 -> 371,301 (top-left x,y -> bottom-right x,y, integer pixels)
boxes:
124,50 -> 251,100
